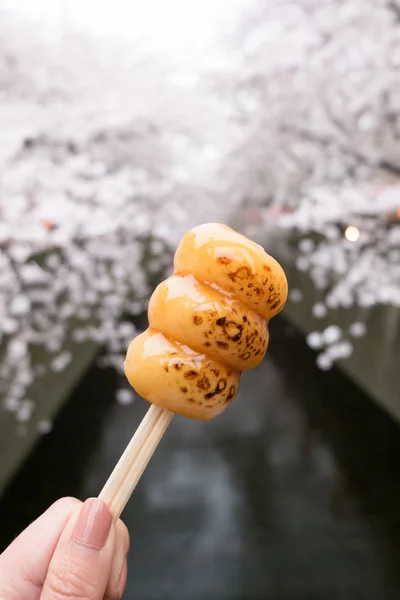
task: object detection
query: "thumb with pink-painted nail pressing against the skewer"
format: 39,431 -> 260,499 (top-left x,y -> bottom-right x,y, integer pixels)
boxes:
41,498 -> 116,600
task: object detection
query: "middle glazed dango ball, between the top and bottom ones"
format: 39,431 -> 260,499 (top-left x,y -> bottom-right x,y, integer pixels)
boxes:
149,275 -> 268,371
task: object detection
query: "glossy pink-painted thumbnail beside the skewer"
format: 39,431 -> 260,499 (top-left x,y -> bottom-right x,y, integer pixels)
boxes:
72,498 -> 113,550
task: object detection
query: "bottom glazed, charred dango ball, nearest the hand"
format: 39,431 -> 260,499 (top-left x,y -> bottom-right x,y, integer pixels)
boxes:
125,329 -> 240,421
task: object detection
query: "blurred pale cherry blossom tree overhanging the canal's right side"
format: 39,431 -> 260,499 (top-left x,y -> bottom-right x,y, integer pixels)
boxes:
215,0 -> 400,368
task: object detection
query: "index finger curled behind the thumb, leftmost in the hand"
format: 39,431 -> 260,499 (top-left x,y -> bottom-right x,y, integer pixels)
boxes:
0,498 -> 82,600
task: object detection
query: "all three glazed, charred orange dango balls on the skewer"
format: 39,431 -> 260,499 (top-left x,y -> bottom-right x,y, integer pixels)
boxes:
125,223 -> 287,421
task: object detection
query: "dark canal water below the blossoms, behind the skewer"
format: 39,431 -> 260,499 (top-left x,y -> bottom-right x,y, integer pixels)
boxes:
0,319 -> 400,600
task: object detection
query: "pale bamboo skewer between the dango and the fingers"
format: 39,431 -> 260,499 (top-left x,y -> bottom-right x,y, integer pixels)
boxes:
99,404 -> 174,519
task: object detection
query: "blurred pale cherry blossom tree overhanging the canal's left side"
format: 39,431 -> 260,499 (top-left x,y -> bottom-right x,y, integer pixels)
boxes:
0,8 -> 241,422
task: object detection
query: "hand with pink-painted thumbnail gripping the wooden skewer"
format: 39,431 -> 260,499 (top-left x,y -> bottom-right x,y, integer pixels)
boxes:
0,498 -> 129,600
